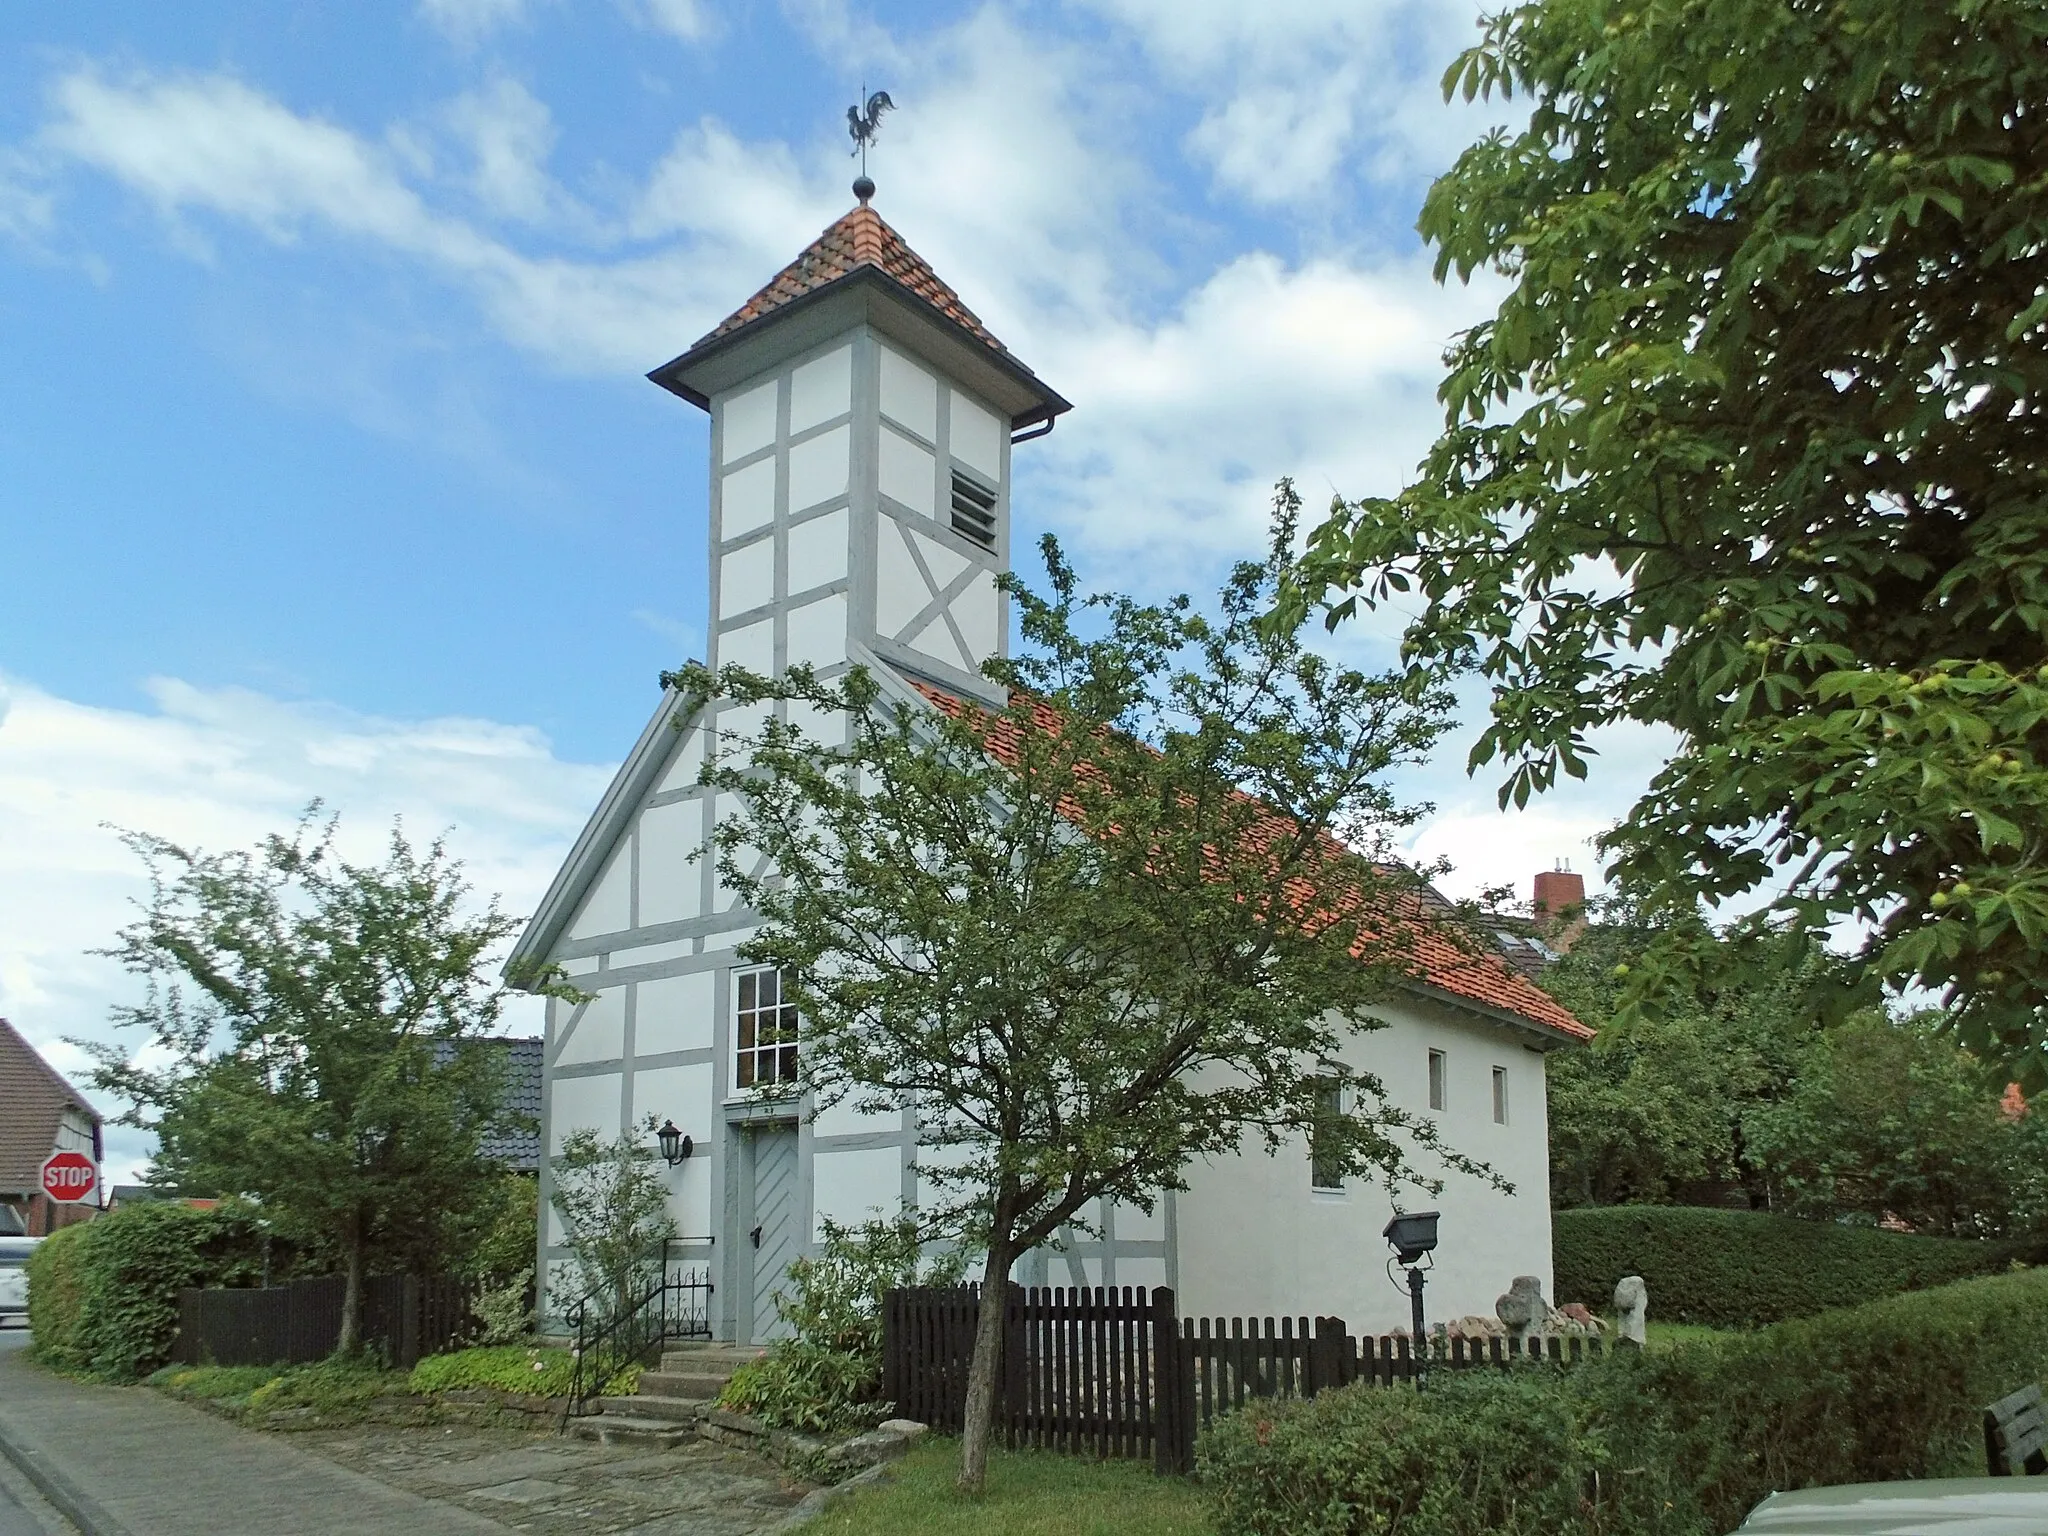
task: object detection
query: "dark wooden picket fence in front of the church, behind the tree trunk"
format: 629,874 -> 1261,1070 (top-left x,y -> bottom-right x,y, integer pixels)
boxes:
883,1286 -> 1602,1473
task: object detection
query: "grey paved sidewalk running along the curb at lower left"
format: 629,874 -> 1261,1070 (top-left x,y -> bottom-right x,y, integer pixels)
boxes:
0,1339 -> 508,1536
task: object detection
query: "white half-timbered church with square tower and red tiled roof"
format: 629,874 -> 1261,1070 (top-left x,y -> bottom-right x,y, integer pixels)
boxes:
512,192 -> 1587,1339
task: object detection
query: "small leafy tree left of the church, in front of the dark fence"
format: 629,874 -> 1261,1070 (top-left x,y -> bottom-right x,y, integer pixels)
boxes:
80,805 -> 559,1352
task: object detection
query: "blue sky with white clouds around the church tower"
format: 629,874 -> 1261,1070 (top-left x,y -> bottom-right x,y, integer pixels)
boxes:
0,0 -> 1647,1179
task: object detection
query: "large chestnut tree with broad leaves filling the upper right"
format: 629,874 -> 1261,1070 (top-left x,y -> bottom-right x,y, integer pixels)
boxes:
1294,0 -> 2048,1085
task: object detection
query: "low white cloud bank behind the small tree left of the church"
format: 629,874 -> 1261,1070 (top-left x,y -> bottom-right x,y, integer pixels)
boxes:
0,674 -> 610,1180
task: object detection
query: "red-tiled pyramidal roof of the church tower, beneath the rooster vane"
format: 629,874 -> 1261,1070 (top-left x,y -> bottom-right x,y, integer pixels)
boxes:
647,196 -> 1071,428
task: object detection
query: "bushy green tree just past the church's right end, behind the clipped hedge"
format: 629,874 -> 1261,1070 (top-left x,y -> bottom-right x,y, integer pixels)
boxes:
1540,909 -> 1825,1206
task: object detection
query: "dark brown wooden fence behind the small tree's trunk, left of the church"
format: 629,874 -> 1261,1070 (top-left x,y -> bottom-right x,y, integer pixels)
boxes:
170,1274 -> 475,1370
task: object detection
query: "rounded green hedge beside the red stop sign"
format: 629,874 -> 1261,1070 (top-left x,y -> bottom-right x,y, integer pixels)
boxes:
29,1202 -> 260,1380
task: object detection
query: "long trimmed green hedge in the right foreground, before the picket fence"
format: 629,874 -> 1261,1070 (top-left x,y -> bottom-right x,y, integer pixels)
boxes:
1198,1272 -> 2048,1536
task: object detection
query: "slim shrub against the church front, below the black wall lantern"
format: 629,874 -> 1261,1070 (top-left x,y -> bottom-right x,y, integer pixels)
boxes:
553,1114 -> 676,1321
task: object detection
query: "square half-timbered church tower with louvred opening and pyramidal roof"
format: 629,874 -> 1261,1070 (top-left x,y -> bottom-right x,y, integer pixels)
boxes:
647,180 -> 1069,702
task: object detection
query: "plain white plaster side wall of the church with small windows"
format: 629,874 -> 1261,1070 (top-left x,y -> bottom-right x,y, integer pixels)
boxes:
1178,999 -> 1550,1331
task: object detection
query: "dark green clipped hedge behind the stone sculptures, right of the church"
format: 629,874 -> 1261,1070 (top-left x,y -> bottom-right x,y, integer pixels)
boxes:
1550,1206 -> 2032,1327
